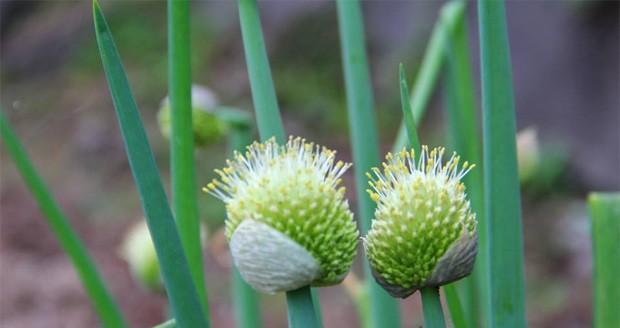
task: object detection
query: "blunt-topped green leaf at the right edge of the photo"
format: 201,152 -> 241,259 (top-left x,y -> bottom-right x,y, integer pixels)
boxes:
588,192 -> 620,328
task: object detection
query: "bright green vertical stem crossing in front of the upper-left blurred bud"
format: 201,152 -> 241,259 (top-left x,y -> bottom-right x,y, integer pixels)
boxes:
168,0 -> 209,317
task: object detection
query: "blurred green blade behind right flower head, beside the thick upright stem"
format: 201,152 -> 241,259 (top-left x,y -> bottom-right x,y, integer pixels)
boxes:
442,1 -> 489,328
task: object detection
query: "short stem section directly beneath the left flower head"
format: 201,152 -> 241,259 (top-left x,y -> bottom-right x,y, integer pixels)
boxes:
286,286 -> 319,328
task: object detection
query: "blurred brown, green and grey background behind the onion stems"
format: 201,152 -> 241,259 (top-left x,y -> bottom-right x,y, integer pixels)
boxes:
0,1 -> 620,327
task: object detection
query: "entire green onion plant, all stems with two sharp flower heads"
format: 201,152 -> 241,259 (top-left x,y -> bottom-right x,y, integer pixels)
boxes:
6,0 -> 604,328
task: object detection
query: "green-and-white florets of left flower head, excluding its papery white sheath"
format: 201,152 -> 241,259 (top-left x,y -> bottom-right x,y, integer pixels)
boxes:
204,137 -> 359,285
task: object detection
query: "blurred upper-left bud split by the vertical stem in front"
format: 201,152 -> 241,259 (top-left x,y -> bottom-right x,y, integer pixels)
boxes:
157,85 -> 228,147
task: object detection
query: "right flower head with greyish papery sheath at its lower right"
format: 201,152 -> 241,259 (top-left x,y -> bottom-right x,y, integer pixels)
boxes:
364,146 -> 478,298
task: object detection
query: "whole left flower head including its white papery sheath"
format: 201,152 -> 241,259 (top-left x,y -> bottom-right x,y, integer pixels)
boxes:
203,137 -> 359,293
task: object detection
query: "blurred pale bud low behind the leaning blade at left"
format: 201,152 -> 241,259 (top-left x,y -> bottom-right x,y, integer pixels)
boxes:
121,221 -> 163,291
